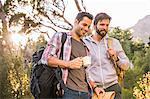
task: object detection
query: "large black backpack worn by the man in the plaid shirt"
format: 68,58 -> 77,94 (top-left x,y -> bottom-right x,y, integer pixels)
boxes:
30,33 -> 67,99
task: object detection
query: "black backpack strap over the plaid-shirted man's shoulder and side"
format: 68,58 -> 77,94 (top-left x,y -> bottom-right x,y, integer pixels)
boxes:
55,32 -> 67,90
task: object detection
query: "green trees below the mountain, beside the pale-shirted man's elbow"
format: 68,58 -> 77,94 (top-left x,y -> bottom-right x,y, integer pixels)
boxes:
109,27 -> 150,99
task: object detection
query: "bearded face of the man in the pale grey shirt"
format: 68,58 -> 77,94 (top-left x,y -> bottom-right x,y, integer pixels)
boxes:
95,19 -> 110,38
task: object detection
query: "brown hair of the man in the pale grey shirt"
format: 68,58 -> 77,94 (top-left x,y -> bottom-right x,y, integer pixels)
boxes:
94,13 -> 111,25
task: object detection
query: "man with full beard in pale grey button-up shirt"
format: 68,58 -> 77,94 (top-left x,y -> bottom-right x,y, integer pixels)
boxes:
84,13 -> 129,99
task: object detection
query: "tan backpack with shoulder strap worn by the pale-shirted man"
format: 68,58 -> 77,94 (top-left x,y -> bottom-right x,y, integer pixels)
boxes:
107,38 -> 125,86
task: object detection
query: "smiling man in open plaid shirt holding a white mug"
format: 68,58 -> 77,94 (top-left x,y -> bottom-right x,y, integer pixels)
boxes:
42,12 -> 93,99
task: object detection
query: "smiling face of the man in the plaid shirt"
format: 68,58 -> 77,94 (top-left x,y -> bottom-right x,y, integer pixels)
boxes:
75,17 -> 92,37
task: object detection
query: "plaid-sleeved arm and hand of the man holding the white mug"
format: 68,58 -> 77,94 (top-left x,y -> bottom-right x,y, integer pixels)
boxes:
41,33 -> 82,69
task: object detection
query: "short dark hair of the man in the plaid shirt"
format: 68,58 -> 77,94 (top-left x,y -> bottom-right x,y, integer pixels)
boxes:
76,12 -> 93,22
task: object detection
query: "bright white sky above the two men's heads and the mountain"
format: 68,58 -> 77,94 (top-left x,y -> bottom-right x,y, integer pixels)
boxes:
67,0 -> 150,29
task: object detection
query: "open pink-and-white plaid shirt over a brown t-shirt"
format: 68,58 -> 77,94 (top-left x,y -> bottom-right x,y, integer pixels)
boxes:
41,32 -> 89,83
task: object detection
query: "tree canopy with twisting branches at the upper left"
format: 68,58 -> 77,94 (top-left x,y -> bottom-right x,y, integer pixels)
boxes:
4,0 -> 86,33
